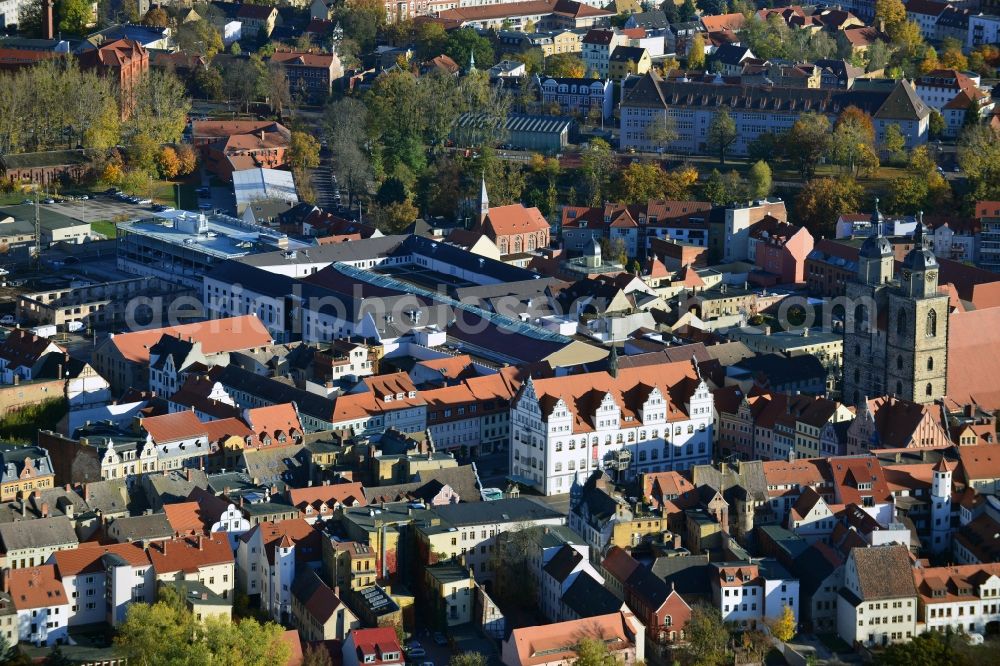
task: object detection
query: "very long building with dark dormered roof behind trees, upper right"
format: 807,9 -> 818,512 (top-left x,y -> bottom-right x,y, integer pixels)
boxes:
616,72 -> 930,155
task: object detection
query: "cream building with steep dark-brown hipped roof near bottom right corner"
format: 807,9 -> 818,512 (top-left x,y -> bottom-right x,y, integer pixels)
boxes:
837,545 -> 918,647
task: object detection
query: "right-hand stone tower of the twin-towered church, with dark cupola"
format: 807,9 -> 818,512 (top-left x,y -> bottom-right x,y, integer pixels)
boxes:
885,220 -> 948,403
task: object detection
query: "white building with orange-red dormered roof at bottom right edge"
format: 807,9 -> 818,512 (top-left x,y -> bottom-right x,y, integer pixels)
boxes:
913,563 -> 1000,634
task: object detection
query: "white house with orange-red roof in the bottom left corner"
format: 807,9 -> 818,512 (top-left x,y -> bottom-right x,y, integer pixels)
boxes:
4,564 -> 71,646
